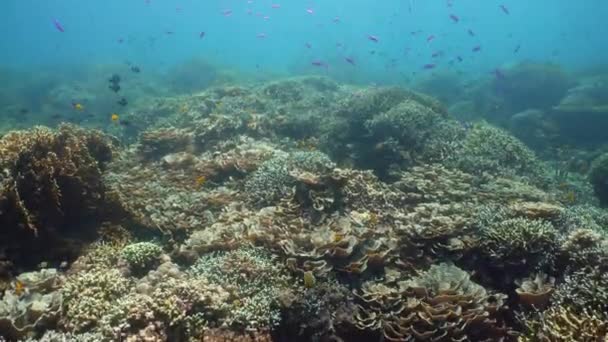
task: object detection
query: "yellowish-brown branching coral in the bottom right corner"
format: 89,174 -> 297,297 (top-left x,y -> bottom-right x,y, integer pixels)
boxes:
518,306 -> 608,342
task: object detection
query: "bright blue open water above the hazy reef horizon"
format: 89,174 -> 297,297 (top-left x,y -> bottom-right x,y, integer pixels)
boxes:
0,0 -> 608,81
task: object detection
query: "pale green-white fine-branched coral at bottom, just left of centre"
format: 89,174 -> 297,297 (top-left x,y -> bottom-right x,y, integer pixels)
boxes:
190,247 -> 292,329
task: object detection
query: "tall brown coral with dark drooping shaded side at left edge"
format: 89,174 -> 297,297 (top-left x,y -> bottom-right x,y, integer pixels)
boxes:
0,125 -> 113,267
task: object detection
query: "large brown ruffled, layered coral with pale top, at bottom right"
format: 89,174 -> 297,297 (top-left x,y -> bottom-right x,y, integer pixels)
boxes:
356,264 -> 507,341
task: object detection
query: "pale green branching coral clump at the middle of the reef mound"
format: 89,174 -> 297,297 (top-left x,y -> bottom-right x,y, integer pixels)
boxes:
245,151 -> 335,205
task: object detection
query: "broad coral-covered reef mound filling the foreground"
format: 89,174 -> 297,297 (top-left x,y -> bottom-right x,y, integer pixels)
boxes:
0,77 -> 608,342
